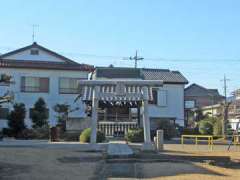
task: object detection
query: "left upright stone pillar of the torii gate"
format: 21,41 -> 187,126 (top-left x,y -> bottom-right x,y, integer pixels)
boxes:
90,86 -> 99,144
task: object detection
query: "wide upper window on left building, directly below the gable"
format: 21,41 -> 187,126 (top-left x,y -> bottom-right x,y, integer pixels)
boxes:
21,77 -> 49,93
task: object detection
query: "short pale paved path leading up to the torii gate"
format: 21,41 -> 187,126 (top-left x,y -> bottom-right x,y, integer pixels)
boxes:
107,142 -> 133,156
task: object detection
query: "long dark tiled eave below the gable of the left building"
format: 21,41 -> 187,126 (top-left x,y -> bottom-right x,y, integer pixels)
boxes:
0,59 -> 94,71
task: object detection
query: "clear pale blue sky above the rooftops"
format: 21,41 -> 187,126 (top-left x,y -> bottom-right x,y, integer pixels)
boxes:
0,0 -> 240,93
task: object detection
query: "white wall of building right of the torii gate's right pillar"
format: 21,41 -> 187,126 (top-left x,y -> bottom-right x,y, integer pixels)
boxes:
149,84 -> 184,126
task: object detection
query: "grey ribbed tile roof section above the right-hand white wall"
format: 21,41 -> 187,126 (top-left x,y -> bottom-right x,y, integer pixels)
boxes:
142,68 -> 188,84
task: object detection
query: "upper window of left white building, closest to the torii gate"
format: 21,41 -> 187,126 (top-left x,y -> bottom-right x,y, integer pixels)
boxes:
59,78 -> 82,94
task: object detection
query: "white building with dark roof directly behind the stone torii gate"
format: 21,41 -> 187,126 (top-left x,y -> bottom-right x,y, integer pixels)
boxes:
86,67 -> 188,130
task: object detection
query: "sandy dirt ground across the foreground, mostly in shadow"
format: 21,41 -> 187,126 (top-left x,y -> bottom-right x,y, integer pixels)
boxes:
0,146 -> 240,180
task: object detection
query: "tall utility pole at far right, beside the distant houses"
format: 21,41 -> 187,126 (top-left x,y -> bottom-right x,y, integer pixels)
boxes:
221,74 -> 230,138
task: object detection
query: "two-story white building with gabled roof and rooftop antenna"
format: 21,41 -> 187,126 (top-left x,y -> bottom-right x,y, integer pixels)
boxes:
0,43 -> 93,128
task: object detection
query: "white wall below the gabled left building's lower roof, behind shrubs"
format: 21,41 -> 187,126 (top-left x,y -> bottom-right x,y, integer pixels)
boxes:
0,68 -> 88,128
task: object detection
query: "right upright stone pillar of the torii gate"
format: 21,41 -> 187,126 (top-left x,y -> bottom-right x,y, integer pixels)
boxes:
142,87 -> 154,150
